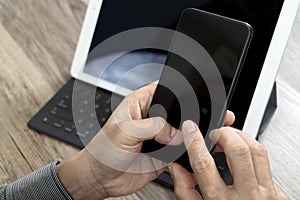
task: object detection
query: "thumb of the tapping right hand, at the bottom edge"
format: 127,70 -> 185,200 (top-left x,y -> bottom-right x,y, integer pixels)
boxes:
169,163 -> 202,200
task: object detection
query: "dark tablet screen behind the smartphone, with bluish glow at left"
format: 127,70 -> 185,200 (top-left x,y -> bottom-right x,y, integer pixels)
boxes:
84,0 -> 284,128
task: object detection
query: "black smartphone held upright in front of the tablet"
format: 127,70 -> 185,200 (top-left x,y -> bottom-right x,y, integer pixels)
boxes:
142,8 -> 253,171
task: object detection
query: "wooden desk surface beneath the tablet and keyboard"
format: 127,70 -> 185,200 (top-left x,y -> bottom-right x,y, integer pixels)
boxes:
0,0 -> 300,199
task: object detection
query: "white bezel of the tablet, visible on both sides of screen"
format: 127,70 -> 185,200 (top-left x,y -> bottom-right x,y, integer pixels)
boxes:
71,0 -> 300,138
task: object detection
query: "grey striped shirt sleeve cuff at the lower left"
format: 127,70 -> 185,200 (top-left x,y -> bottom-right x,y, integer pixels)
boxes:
0,161 -> 72,200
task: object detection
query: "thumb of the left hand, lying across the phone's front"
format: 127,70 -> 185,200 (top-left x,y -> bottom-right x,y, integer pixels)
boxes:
117,117 -> 183,145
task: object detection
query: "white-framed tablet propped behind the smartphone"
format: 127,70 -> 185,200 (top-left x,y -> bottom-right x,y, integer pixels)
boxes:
71,0 -> 299,137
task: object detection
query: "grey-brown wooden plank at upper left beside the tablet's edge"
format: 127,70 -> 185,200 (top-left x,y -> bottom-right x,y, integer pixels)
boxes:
1,0 -> 86,90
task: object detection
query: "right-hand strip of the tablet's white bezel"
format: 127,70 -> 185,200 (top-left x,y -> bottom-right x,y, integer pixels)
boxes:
243,0 -> 300,138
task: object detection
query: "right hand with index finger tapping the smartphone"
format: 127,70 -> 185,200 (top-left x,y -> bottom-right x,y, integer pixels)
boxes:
169,121 -> 288,200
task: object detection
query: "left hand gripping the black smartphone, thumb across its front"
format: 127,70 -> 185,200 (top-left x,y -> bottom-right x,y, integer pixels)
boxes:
57,83 -> 232,199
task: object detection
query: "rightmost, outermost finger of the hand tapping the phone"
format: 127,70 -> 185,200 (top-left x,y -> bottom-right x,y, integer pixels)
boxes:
238,132 -> 274,190
